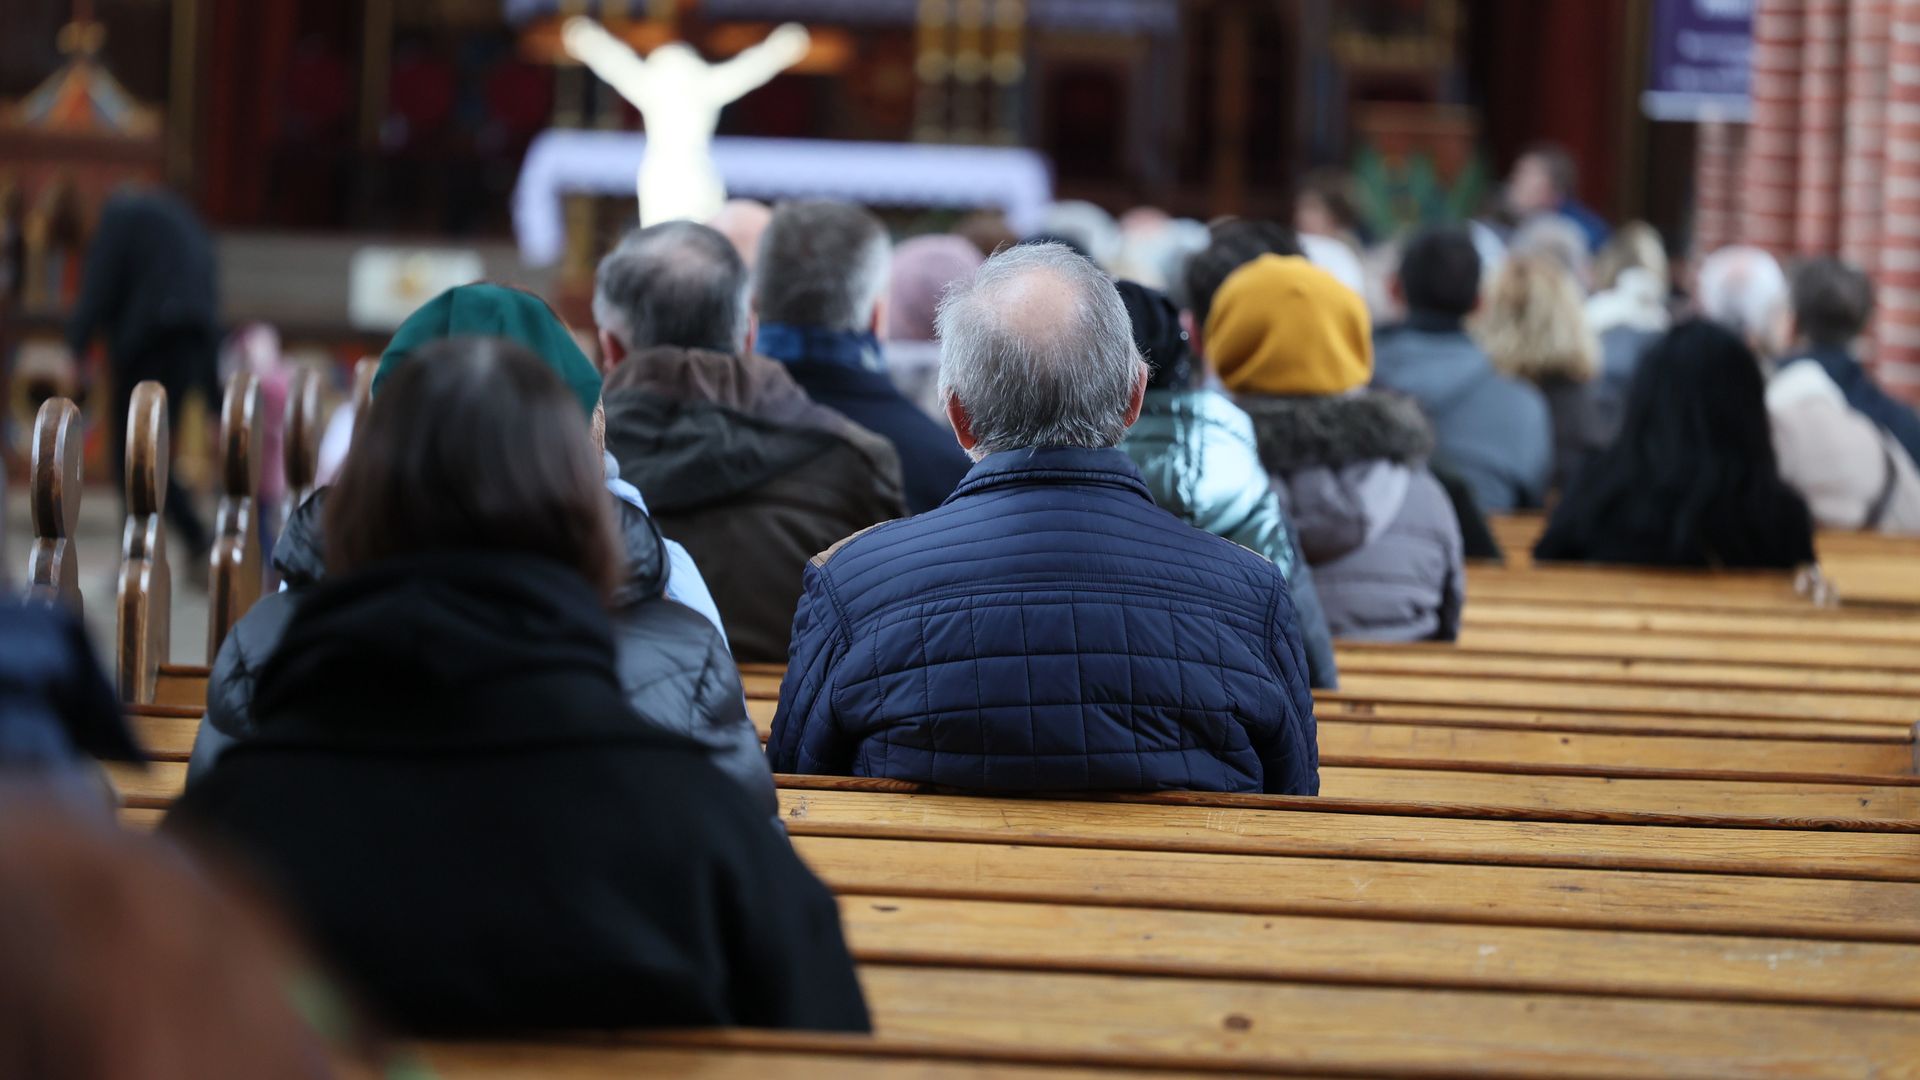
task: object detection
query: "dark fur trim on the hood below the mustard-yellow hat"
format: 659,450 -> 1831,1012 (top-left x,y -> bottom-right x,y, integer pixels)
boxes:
1238,390 -> 1434,475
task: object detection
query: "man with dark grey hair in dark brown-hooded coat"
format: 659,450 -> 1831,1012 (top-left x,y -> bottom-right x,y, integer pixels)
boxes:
593,221 -> 906,663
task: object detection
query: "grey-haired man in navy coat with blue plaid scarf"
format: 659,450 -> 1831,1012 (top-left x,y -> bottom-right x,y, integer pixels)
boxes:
753,202 -> 968,513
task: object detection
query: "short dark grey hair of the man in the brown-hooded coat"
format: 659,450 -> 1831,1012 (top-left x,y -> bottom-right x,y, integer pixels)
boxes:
593,221 -> 747,352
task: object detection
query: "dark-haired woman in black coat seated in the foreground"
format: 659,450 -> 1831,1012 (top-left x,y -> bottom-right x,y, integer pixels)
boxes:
165,338 -> 868,1034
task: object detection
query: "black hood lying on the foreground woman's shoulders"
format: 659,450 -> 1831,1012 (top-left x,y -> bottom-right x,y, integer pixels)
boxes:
253,552 -> 636,746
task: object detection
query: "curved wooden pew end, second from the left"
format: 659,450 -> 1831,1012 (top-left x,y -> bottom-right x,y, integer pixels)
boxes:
113,380 -> 173,703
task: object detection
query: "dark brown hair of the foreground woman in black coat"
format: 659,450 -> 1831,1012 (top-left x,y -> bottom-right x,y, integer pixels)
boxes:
326,338 -> 620,596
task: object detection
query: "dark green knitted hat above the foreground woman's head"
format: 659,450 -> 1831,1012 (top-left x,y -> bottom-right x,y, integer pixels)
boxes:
372,284 -> 599,417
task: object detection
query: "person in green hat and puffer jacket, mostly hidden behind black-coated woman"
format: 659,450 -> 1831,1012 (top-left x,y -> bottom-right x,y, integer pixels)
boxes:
188,284 -> 778,815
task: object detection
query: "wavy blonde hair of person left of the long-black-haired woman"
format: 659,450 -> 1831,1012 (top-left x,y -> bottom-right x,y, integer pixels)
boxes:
1471,254 -> 1599,382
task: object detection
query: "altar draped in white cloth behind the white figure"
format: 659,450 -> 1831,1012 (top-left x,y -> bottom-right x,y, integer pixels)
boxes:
513,129 -> 1054,265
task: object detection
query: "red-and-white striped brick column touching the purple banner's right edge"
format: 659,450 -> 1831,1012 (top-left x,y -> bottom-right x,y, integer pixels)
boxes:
1740,0 -> 1807,258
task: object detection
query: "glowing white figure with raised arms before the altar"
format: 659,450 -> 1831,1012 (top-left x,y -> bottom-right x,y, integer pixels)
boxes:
561,15 -> 812,225
